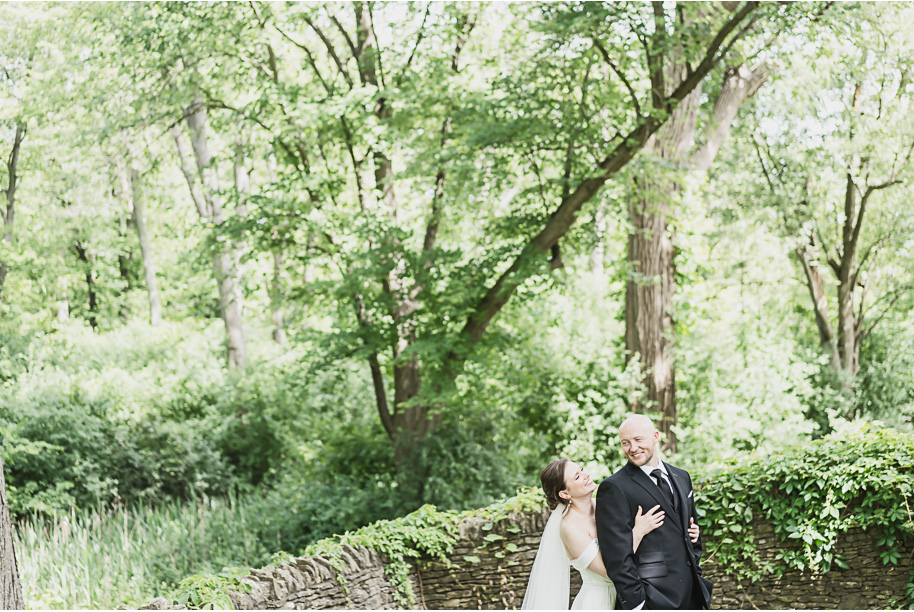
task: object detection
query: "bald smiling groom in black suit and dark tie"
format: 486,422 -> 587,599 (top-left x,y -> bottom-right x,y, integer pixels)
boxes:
596,414 -> 712,610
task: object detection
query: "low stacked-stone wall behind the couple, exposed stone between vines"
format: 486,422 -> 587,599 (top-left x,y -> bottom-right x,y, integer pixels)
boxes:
137,512 -> 912,610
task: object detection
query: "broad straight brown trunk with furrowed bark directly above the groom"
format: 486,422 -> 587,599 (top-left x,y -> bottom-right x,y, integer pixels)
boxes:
625,59 -> 769,452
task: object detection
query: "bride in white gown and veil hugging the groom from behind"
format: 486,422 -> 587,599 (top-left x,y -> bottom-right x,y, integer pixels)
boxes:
521,459 -> 698,610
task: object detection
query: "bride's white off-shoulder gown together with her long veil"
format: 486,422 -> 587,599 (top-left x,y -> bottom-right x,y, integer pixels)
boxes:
521,506 -> 616,610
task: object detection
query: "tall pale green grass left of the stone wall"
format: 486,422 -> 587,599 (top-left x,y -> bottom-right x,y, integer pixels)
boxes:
15,497 -> 271,609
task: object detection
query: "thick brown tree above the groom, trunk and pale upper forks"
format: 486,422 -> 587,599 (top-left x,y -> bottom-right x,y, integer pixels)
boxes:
620,2 -> 769,452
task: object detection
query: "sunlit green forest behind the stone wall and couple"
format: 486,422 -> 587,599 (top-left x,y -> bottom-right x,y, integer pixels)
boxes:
0,2 -> 914,608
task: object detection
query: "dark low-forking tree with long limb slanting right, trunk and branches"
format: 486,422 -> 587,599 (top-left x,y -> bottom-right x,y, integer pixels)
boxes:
253,3 -> 763,482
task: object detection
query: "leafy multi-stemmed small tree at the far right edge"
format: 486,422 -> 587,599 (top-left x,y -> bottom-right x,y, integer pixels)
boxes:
754,6 -> 914,418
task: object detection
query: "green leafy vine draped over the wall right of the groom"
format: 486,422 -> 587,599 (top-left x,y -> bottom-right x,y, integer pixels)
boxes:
696,426 -> 914,592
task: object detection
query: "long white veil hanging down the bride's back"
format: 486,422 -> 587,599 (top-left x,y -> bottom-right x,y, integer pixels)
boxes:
521,505 -> 571,610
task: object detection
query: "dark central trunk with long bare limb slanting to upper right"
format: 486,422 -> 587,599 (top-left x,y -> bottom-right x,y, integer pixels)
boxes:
334,2 -> 758,479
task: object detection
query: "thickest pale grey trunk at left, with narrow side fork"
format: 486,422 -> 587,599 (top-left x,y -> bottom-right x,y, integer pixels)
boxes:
183,97 -> 247,369
